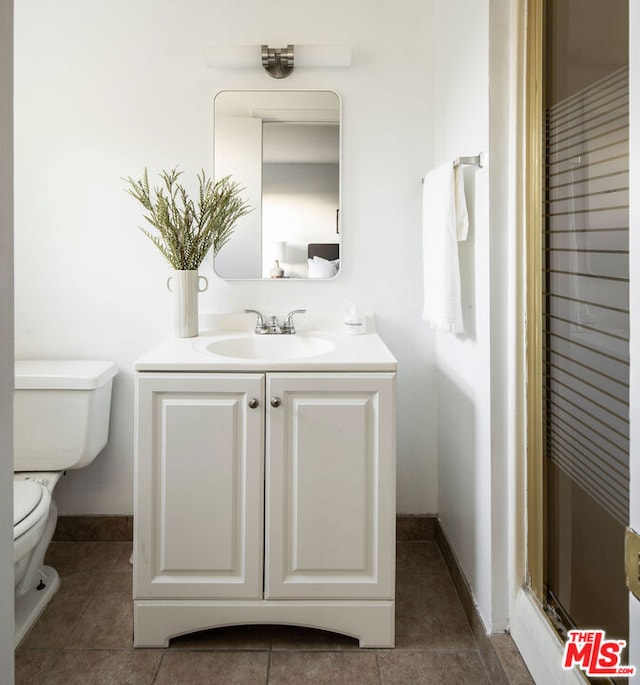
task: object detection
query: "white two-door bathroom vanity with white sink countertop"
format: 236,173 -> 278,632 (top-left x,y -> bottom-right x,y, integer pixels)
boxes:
134,316 -> 396,647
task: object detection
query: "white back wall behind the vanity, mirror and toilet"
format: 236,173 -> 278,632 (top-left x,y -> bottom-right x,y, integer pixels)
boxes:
15,0 -> 440,512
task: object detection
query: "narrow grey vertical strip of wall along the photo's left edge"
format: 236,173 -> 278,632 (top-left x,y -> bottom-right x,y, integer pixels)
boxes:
0,0 -> 14,685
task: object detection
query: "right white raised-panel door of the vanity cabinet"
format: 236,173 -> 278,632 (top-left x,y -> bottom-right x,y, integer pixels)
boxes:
265,373 -> 395,599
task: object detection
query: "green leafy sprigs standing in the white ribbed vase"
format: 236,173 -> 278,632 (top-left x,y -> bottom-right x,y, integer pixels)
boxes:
123,167 -> 251,270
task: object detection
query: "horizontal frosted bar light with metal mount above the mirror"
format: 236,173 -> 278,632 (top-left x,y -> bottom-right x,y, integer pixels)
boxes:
204,45 -> 351,78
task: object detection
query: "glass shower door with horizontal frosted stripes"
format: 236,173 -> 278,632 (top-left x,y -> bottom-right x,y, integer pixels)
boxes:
543,0 -> 629,656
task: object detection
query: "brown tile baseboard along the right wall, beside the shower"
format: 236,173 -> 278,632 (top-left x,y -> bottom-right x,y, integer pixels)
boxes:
435,519 -> 535,685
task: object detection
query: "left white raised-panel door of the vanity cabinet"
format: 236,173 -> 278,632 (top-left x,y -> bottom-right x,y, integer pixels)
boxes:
134,373 -> 264,599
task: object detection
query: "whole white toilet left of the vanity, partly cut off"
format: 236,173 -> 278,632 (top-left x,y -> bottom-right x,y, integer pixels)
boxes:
13,360 -> 117,645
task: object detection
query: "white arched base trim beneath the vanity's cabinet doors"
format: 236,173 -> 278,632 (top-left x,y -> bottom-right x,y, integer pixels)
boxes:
133,600 -> 395,648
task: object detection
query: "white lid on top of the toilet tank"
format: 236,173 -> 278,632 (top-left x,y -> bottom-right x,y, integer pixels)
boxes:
15,359 -> 118,390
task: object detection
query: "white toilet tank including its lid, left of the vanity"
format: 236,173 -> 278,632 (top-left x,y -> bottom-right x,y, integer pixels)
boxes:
13,360 -> 117,471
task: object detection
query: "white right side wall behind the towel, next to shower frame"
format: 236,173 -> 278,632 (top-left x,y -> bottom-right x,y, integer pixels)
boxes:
434,0 -> 510,631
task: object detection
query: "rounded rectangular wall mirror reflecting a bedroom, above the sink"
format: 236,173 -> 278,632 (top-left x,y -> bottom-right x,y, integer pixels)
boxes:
214,90 -> 340,278
